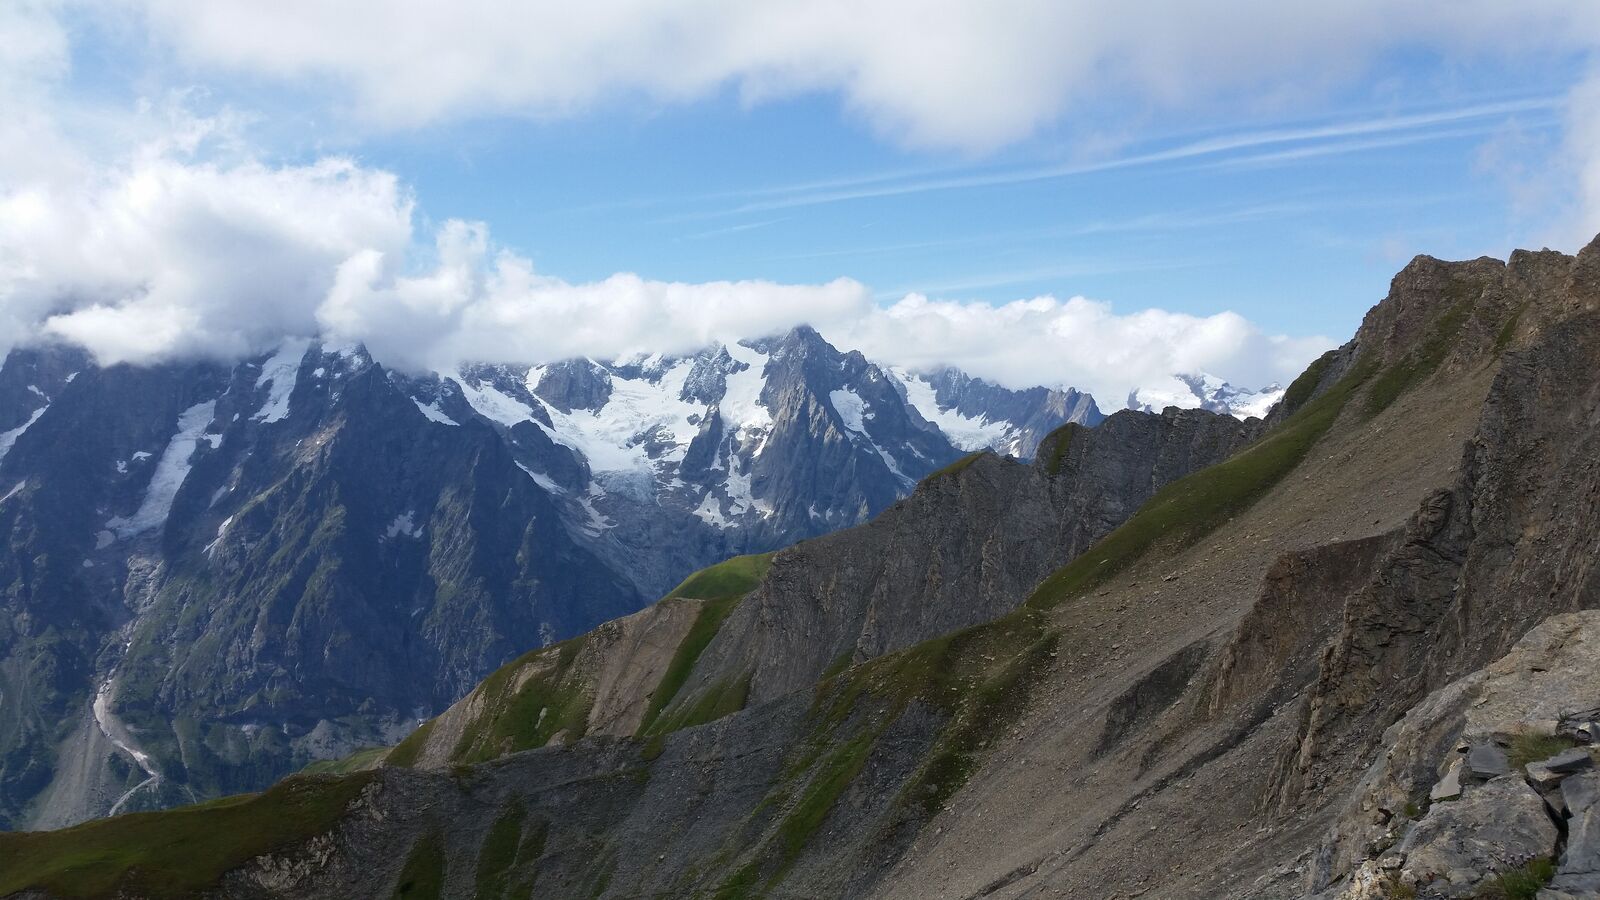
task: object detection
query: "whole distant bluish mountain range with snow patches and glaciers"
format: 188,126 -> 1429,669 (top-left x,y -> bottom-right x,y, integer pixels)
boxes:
0,328 -> 1101,828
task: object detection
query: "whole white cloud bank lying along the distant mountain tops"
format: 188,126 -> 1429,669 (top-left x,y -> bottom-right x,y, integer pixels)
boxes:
0,120 -> 1330,397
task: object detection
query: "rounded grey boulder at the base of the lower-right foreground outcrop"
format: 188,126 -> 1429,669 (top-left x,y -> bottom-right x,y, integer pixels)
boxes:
1400,777 -> 1557,897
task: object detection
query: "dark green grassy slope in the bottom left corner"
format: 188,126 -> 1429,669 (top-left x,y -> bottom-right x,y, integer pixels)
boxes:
0,773 -> 371,898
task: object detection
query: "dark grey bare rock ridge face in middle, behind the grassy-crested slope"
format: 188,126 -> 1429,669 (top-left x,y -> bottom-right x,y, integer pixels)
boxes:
680,400 -> 1259,703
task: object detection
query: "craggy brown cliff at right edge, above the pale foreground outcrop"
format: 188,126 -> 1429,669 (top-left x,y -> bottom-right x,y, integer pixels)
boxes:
1285,245 -> 1600,816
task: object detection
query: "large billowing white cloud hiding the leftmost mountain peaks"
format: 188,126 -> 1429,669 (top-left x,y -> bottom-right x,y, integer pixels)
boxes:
0,128 -> 411,364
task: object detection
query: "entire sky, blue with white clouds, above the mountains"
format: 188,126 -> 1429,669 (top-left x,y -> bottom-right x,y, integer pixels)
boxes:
0,0 -> 1600,397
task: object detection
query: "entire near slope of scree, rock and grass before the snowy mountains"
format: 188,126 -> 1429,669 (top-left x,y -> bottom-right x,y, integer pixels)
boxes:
0,240 -> 1600,898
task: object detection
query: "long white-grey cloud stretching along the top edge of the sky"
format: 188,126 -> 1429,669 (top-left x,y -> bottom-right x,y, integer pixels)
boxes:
123,0 -> 1600,149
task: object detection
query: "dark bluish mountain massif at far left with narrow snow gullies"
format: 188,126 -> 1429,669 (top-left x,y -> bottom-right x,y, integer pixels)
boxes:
0,343 -> 642,825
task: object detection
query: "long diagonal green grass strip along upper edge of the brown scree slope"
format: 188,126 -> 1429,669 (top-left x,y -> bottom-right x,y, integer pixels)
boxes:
1026,353 -> 1371,609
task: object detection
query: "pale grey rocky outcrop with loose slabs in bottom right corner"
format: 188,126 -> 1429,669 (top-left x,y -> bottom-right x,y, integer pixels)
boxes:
1318,610 -> 1600,900
